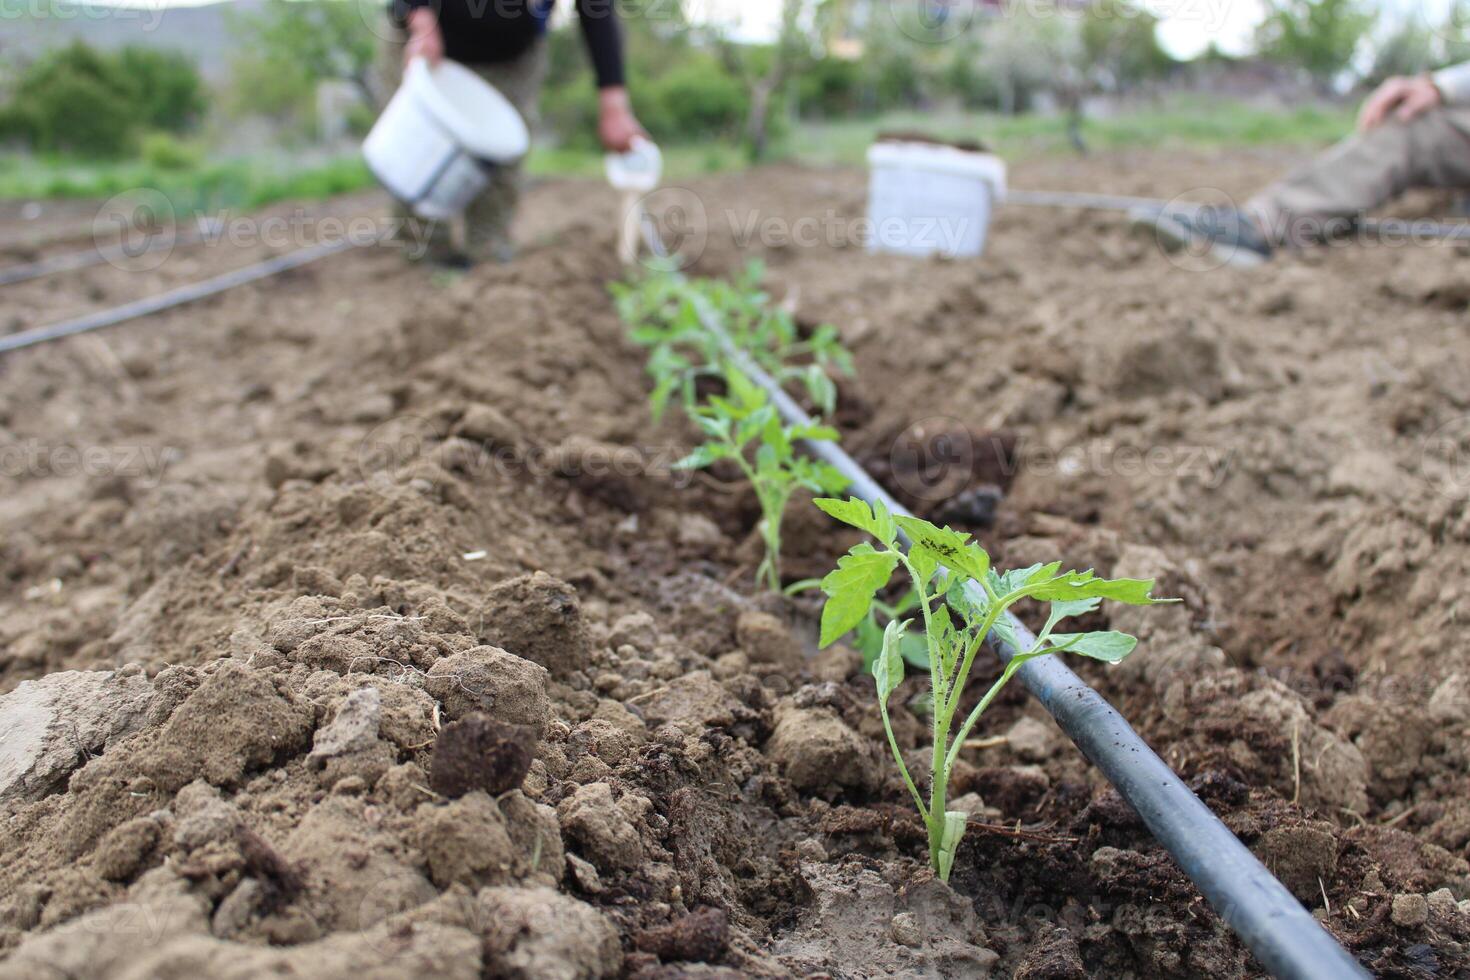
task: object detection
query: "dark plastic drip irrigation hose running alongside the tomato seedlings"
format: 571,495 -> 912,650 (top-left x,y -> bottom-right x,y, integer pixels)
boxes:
642,216 -> 1369,980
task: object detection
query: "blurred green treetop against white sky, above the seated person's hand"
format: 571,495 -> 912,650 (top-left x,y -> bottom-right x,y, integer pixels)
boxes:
1257,0 -> 1377,93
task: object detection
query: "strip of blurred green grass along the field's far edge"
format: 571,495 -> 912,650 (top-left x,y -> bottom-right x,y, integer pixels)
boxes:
0,96 -> 1352,213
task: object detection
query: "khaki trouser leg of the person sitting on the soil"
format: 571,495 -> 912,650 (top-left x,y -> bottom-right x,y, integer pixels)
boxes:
1245,109 -> 1470,244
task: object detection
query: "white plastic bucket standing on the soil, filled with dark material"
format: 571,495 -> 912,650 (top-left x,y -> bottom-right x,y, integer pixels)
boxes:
867,141 -> 1005,257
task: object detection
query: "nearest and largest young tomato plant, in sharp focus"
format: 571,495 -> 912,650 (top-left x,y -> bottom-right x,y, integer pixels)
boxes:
816,498 -> 1172,880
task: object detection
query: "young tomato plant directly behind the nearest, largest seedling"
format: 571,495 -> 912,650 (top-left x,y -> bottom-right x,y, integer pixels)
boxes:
675,369 -> 847,592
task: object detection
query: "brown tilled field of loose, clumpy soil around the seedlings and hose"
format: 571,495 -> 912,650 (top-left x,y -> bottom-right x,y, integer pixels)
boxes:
0,156 -> 1470,979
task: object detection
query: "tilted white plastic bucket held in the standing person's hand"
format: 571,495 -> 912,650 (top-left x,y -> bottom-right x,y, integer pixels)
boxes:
363,59 -> 531,220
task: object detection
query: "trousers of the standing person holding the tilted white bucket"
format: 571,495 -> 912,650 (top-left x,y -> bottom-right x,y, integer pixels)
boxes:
378,29 -> 547,262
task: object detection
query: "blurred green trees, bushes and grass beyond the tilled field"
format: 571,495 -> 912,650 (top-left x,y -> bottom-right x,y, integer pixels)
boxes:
0,0 -> 1470,207
